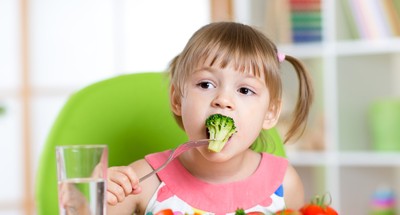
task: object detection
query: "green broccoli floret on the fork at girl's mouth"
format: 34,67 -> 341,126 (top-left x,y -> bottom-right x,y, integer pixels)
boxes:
206,114 -> 236,152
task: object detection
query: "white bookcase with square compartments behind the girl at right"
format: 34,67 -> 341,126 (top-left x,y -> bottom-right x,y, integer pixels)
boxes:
251,0 -> 400,214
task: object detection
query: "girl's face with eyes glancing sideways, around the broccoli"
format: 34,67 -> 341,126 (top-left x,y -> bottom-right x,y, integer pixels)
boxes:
171,65 -> 279,160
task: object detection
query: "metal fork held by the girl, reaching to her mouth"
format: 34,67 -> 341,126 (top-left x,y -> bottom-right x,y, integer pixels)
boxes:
139,139 -> 210,182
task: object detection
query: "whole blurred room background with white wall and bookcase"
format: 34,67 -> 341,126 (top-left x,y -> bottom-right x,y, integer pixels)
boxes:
0,0 -> 400,215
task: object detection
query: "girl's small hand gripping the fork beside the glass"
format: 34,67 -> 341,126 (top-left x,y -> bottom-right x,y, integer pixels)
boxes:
107,166 -> 141,205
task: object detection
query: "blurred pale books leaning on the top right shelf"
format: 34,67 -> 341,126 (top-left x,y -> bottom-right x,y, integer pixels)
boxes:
341,0 -> 400,39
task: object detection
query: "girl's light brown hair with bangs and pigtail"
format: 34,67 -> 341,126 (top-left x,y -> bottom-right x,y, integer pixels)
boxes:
169,22 -> 313,142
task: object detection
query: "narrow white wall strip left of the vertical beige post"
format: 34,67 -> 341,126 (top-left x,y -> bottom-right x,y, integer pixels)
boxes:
0,0 -> 23,208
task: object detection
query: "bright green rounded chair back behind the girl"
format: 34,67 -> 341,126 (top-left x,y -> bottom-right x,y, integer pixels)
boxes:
36,72 -> 284,215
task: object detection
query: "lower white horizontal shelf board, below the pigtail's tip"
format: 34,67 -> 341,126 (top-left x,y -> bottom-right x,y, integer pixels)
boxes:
287,151 -> 400,167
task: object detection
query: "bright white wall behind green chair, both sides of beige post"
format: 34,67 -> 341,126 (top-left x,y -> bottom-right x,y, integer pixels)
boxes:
0,0 -> 210,214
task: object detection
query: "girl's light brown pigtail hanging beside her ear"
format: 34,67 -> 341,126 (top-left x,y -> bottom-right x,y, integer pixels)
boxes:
284,55 -> 314,143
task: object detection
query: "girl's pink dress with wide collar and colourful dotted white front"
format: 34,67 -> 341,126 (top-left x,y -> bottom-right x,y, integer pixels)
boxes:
145,150 -> 288,215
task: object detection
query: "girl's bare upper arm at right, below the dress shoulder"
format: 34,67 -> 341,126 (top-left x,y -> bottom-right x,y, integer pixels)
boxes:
283,164 -> 304,210
